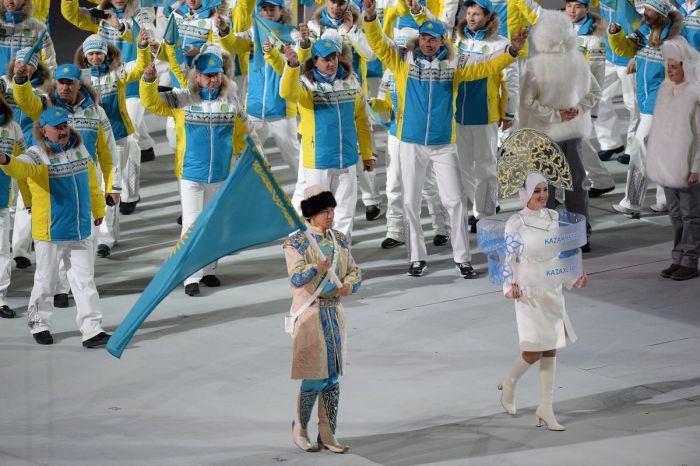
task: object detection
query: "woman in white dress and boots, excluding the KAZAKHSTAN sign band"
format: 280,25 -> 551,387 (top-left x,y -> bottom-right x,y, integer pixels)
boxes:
498,172 -> 588,430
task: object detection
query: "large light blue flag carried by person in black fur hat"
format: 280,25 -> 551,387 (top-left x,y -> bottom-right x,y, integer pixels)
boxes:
107,138 -> 306,358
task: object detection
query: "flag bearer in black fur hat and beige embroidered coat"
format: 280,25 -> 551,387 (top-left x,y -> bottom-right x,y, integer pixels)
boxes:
284,185 -> 362,453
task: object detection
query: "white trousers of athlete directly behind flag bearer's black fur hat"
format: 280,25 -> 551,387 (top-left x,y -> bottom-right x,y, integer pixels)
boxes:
304,162 -> 359,241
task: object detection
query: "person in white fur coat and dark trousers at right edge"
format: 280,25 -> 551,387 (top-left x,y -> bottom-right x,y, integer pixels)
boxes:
647,37 -> 700,280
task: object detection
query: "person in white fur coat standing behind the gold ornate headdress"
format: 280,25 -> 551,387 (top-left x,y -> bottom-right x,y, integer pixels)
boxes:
520,10 -> 601,252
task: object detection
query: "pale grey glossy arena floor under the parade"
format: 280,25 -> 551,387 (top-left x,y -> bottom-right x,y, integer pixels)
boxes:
0,107 -> 700,466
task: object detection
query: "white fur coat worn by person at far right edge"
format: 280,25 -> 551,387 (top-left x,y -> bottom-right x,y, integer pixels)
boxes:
647,79 -> 700,188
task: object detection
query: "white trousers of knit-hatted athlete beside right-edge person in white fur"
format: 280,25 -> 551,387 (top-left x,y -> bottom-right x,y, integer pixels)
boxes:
620,114 -> 666,210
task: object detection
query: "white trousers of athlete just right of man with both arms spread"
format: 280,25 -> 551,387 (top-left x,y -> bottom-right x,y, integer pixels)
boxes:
457,123 -> 498,218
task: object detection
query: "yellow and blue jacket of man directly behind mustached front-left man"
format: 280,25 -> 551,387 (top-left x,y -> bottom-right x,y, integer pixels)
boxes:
12,80 -> 116,192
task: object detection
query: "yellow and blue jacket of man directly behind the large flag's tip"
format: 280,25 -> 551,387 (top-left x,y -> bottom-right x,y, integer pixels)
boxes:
139,77 -> 255,183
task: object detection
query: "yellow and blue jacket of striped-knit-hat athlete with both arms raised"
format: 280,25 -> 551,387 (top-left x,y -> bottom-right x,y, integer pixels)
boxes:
75,47 -> 151,140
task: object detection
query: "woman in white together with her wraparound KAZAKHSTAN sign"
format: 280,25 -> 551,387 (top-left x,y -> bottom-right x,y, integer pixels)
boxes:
498,172 -> 588,430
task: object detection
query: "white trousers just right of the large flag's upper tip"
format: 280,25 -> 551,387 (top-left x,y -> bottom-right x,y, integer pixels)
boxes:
249,116 -> 304,205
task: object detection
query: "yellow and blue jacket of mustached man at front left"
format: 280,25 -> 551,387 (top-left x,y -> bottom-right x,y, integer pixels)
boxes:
0,131 -> 105,241
